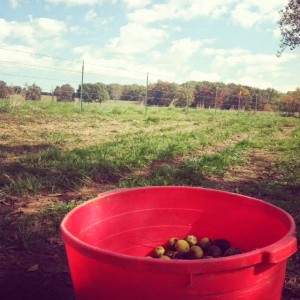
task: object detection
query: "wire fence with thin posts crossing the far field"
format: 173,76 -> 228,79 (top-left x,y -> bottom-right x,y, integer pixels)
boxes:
0,47 -> 286,111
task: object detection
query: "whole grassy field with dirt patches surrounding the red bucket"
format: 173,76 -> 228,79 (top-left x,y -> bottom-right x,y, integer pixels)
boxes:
0,99 -> 300,300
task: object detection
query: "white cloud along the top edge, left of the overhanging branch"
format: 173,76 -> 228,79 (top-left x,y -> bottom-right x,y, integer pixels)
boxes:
128,0 -> 288,28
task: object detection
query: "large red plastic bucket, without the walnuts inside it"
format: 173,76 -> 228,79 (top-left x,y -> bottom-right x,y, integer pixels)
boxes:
61,187 -> 297,300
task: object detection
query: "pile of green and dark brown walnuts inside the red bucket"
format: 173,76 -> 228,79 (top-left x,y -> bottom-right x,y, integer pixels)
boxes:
148,234 -> 241,259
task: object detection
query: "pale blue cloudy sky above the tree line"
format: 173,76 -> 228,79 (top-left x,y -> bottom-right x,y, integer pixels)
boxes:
0,0 -> 300,92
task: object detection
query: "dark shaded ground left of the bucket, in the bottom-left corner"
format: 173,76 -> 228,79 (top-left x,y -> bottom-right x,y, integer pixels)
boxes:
0,203 -> 78,300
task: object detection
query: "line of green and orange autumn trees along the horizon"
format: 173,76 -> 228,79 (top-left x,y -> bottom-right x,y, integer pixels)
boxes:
0,80 -> 300,114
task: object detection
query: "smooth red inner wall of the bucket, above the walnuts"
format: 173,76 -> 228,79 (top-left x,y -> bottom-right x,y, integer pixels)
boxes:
65,187 -> 291,257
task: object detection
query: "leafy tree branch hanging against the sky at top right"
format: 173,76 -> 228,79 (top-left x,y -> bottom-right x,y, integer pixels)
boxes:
278,0 -> 300,56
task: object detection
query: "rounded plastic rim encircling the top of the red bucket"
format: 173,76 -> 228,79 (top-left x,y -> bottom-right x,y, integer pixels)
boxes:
60,186 -> 297,273
